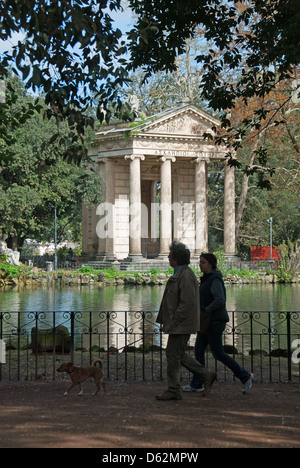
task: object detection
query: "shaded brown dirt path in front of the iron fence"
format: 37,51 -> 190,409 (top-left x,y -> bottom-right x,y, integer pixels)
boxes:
0,380 -> 300,449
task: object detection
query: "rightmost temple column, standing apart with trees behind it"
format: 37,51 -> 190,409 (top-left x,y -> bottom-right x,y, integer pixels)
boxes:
224,162 -> 236,257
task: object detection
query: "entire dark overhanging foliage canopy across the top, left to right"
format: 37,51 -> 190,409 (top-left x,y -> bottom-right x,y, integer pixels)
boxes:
0,0 -> 300,170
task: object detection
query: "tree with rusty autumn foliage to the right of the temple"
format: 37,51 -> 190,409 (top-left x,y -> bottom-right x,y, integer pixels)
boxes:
232,68 -> 300,241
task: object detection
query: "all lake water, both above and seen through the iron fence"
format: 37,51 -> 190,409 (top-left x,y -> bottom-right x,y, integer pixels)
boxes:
0,284 -> 300,350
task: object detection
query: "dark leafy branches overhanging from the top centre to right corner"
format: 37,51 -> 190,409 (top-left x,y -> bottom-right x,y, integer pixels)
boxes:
129,0 -> 300,165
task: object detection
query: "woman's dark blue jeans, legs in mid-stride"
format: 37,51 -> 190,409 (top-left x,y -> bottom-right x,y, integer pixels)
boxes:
191,322 -> 250,388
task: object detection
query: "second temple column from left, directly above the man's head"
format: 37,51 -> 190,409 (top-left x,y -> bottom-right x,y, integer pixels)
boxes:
159,156 -> 176,258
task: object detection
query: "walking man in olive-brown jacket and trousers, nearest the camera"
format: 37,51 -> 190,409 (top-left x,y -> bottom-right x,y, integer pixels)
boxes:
156,242 -> 217,401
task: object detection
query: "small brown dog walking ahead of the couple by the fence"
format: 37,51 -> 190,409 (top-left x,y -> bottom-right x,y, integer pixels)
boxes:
57,359 -> 106,395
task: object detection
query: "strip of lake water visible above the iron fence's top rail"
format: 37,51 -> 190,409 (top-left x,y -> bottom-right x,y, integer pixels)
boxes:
0,284 -> 300,312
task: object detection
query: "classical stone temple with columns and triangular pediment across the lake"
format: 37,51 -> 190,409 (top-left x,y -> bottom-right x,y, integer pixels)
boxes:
82,102 -> 235,261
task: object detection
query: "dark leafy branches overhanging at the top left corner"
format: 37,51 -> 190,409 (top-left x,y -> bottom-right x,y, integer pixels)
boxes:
0,0 -> 131,160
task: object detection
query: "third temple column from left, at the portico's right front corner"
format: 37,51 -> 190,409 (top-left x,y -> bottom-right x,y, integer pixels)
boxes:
193,158 -> 209,255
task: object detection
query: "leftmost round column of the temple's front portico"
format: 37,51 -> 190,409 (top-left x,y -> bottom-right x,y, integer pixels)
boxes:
125,155 -> 145,259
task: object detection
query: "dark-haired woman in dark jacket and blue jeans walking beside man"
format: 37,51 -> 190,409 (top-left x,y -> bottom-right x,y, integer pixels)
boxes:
182,253 -> 254,394
